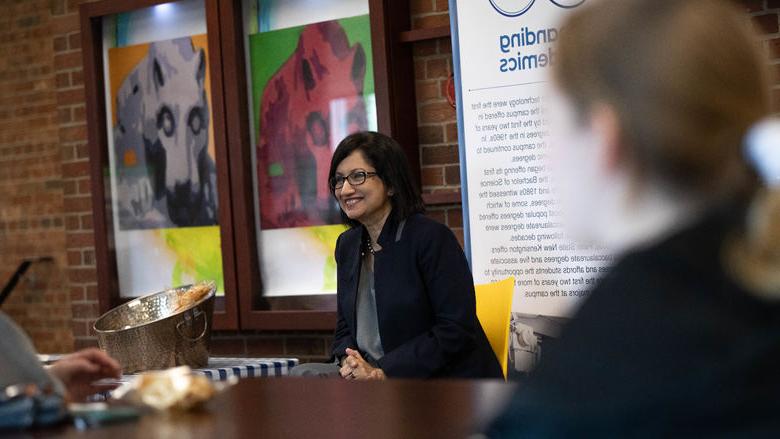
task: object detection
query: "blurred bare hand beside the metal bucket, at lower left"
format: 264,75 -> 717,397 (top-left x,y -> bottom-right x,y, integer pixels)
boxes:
48,348 -> 122,401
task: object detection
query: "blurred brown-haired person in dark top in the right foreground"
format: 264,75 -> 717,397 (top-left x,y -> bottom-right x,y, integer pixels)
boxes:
488,0 -> 780,437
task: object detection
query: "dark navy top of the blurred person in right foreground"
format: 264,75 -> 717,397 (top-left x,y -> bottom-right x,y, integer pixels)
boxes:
490,205 -> 780,437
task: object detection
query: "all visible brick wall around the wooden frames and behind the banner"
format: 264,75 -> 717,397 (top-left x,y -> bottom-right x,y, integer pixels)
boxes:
0,0 -> 780,361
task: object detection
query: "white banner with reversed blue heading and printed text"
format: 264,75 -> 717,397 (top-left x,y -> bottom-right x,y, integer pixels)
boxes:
450,0 -> 610,316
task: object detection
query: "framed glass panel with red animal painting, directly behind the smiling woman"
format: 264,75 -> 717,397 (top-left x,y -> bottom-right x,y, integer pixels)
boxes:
244,0 -> 376,309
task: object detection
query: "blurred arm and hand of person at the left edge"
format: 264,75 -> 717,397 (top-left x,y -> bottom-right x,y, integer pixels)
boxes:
0,312 -> 121,402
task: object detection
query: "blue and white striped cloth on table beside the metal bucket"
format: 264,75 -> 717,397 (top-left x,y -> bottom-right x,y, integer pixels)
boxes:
192,357 -> 298,381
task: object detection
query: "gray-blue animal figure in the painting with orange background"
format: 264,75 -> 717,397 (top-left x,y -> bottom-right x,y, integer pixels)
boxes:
114,37 -> 217,230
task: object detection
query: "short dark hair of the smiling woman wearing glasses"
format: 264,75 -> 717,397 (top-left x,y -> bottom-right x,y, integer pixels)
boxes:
328,131 -> 425,227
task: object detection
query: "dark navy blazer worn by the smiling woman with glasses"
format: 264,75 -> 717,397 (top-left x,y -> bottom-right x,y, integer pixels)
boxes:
333,214 -> 502,378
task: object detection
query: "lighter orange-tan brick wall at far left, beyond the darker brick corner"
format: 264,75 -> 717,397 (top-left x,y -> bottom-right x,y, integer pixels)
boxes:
0,0 -> 73,352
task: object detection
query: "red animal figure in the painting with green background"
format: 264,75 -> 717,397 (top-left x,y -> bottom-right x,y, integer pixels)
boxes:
254,17 -> 373,229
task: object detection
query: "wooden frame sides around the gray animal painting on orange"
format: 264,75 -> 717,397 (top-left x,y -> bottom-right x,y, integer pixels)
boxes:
79,0 -> 238,329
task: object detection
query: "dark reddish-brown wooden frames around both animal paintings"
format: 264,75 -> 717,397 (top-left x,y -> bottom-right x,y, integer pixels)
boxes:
80,0 -> 426,330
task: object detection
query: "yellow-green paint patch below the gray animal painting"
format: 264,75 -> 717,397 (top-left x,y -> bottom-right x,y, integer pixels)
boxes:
159,226 -> 225,296
